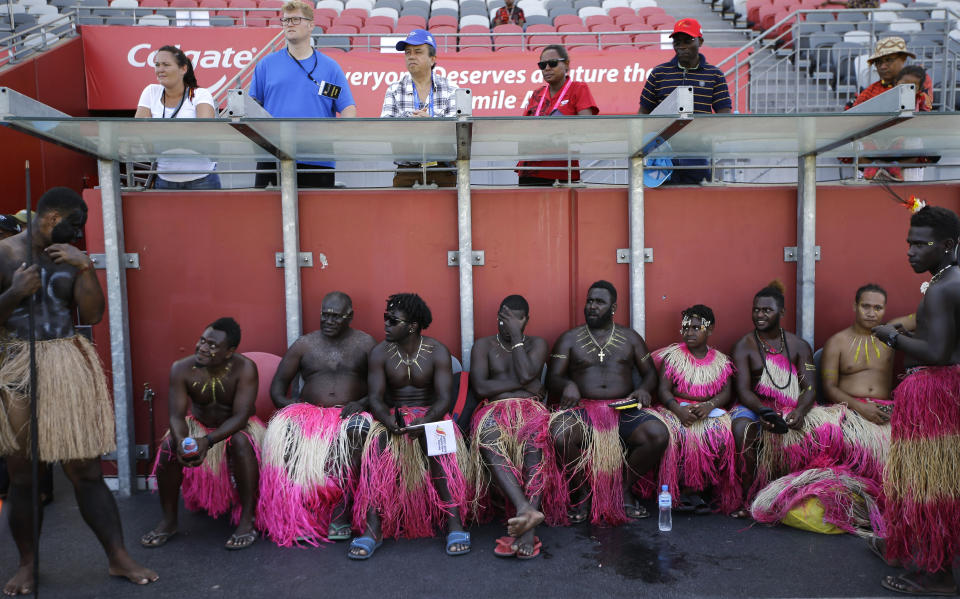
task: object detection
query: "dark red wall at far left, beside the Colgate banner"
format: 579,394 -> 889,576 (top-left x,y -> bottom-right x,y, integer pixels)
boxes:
0,37 -> 97,214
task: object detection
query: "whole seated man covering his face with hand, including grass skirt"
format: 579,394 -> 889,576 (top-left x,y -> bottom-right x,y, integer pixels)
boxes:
470,295 -> 559,559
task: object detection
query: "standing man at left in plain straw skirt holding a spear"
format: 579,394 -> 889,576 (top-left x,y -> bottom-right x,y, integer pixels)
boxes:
0,187 -> 158,595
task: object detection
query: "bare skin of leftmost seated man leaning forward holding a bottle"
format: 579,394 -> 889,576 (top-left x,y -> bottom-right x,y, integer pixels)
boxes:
141,327 -> 260,546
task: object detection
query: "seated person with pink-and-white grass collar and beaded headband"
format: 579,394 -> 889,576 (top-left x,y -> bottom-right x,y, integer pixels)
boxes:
653,304 -> 740,513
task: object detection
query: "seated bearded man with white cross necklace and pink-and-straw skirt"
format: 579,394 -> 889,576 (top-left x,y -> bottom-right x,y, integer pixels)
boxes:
547,281 -> 670,524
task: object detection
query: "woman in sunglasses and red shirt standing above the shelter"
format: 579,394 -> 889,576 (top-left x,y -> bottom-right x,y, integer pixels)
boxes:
517,44 -> 600,186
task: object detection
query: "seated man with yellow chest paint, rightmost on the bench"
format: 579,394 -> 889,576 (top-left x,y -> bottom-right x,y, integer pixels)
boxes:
820,284 -> 894,481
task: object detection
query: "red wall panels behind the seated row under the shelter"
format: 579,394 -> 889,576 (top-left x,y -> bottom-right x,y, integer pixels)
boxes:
84,185 -> 960,464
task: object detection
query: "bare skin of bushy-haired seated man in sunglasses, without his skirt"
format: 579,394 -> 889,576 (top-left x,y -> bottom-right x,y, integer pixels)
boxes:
350,302 -> 467,555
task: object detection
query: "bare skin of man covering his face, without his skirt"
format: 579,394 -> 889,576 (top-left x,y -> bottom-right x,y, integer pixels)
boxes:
470,306 -> 547,556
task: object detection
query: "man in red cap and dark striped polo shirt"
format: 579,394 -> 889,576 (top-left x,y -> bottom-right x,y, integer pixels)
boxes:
640,19 -> 733,185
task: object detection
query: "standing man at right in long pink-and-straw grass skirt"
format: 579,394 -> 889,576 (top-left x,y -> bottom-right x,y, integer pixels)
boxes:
873,203 -> 960,595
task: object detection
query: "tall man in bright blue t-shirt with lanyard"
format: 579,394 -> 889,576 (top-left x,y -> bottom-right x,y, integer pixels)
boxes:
250,0 -> 357,187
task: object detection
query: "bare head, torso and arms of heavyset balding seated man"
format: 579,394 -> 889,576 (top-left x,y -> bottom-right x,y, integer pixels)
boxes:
270,292 -> 376,417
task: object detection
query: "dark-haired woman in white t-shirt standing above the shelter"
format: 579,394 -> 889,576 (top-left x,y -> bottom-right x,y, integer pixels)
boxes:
134,46 -> 220,189
